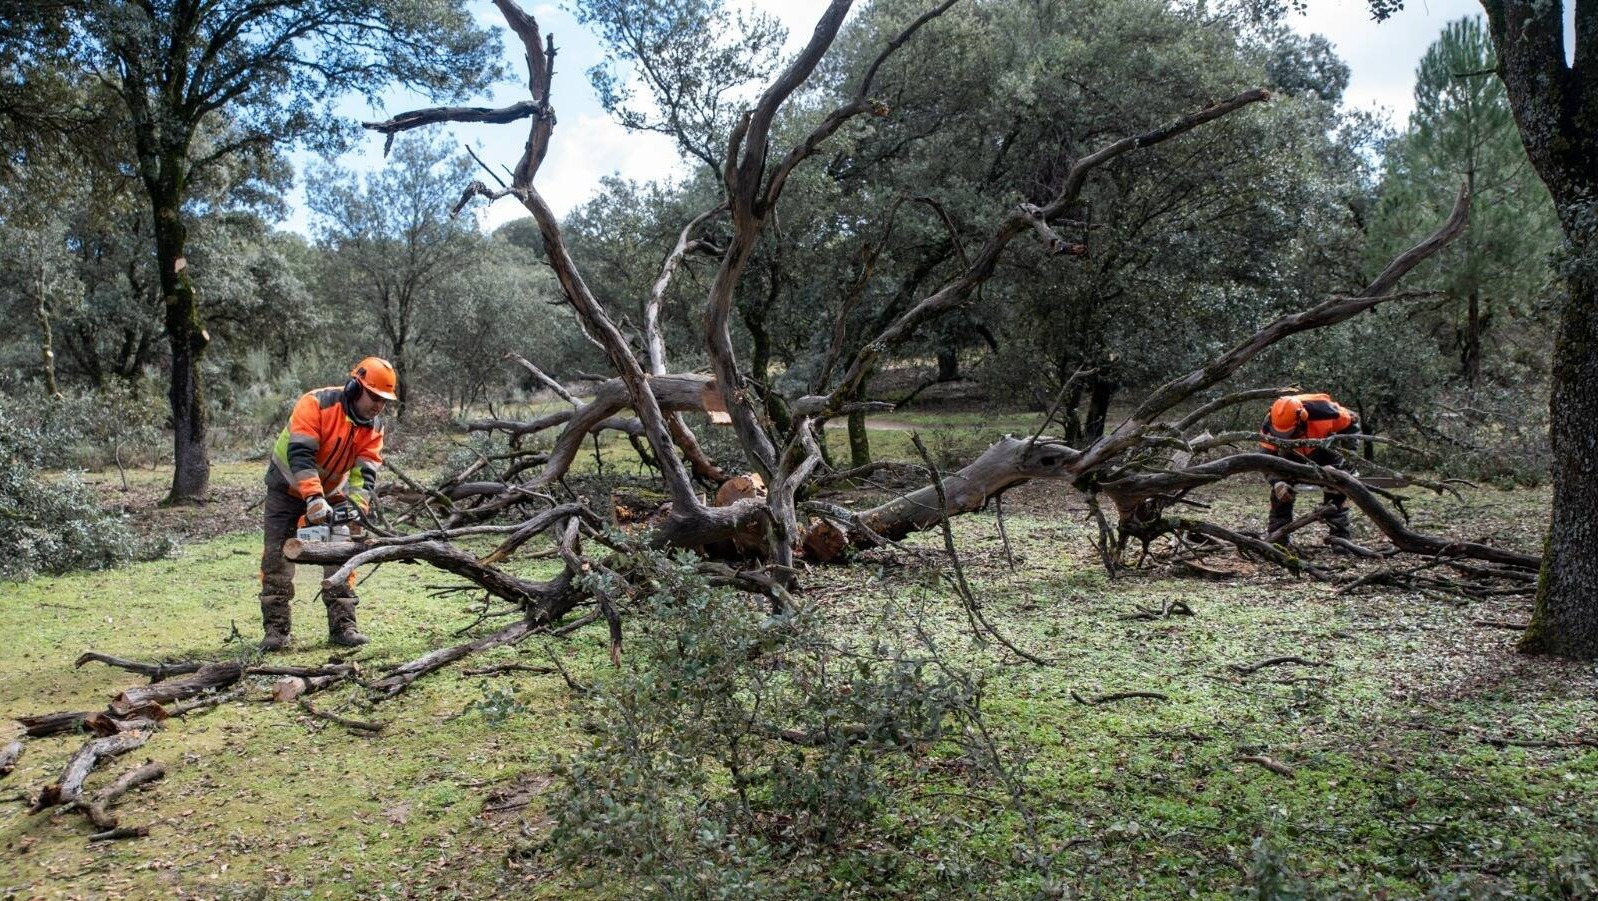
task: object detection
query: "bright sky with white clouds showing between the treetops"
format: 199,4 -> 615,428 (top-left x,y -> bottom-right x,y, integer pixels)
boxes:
284,0 -> 1574,233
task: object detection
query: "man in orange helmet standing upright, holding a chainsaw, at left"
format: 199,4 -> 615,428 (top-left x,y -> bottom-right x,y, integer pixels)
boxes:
260,356 -> 400,650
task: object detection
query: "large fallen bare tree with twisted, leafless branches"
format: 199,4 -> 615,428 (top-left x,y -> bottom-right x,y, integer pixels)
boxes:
343,0 -> 1537,613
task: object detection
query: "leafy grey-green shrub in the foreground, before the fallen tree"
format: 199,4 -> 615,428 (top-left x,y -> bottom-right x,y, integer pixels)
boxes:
550,554 -> 997,898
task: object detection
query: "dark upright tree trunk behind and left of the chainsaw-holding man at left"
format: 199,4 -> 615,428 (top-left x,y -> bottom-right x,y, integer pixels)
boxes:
153,184 -> 211,505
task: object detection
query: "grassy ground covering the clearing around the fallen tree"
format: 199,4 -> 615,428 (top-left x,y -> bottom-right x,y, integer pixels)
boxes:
0,431 -> 1598,898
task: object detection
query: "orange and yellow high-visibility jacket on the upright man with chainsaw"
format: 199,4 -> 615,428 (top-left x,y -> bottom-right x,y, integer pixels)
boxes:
267,385 -> 384,506
